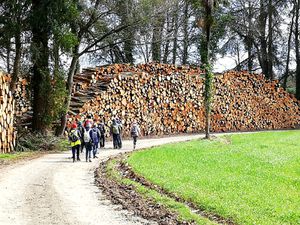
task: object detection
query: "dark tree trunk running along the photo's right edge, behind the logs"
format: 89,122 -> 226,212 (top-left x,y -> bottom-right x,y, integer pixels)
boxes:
294,0 -> 300,99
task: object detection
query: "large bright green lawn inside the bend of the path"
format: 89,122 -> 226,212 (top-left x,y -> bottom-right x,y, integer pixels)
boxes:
128,131 -> 300,225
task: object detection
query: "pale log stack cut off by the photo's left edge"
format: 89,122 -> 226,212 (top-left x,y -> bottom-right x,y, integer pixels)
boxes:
0,72 -> 16,153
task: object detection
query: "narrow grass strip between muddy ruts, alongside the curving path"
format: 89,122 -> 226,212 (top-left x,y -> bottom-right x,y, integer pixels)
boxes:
107,160 -> 217,225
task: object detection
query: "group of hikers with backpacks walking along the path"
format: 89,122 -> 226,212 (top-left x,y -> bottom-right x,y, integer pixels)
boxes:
68,116 -> 141,162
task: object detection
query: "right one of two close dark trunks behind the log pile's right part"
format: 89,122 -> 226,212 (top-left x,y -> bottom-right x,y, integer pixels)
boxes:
268,0 -> 274,80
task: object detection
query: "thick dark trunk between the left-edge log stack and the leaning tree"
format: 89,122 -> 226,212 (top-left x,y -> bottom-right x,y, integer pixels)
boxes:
31,0 -> 51,134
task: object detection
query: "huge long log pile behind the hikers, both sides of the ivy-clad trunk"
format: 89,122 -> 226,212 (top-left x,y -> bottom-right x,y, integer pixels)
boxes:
70,63 -> 300,136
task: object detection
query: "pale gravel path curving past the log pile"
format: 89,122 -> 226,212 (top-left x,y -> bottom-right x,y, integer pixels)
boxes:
0,135 -> 203,225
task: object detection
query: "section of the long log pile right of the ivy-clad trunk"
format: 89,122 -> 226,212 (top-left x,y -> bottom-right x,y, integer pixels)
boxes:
212,72 -> 300,132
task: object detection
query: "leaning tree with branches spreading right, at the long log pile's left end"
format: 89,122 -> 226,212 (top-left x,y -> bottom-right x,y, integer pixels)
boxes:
57,0 -> 132,135
